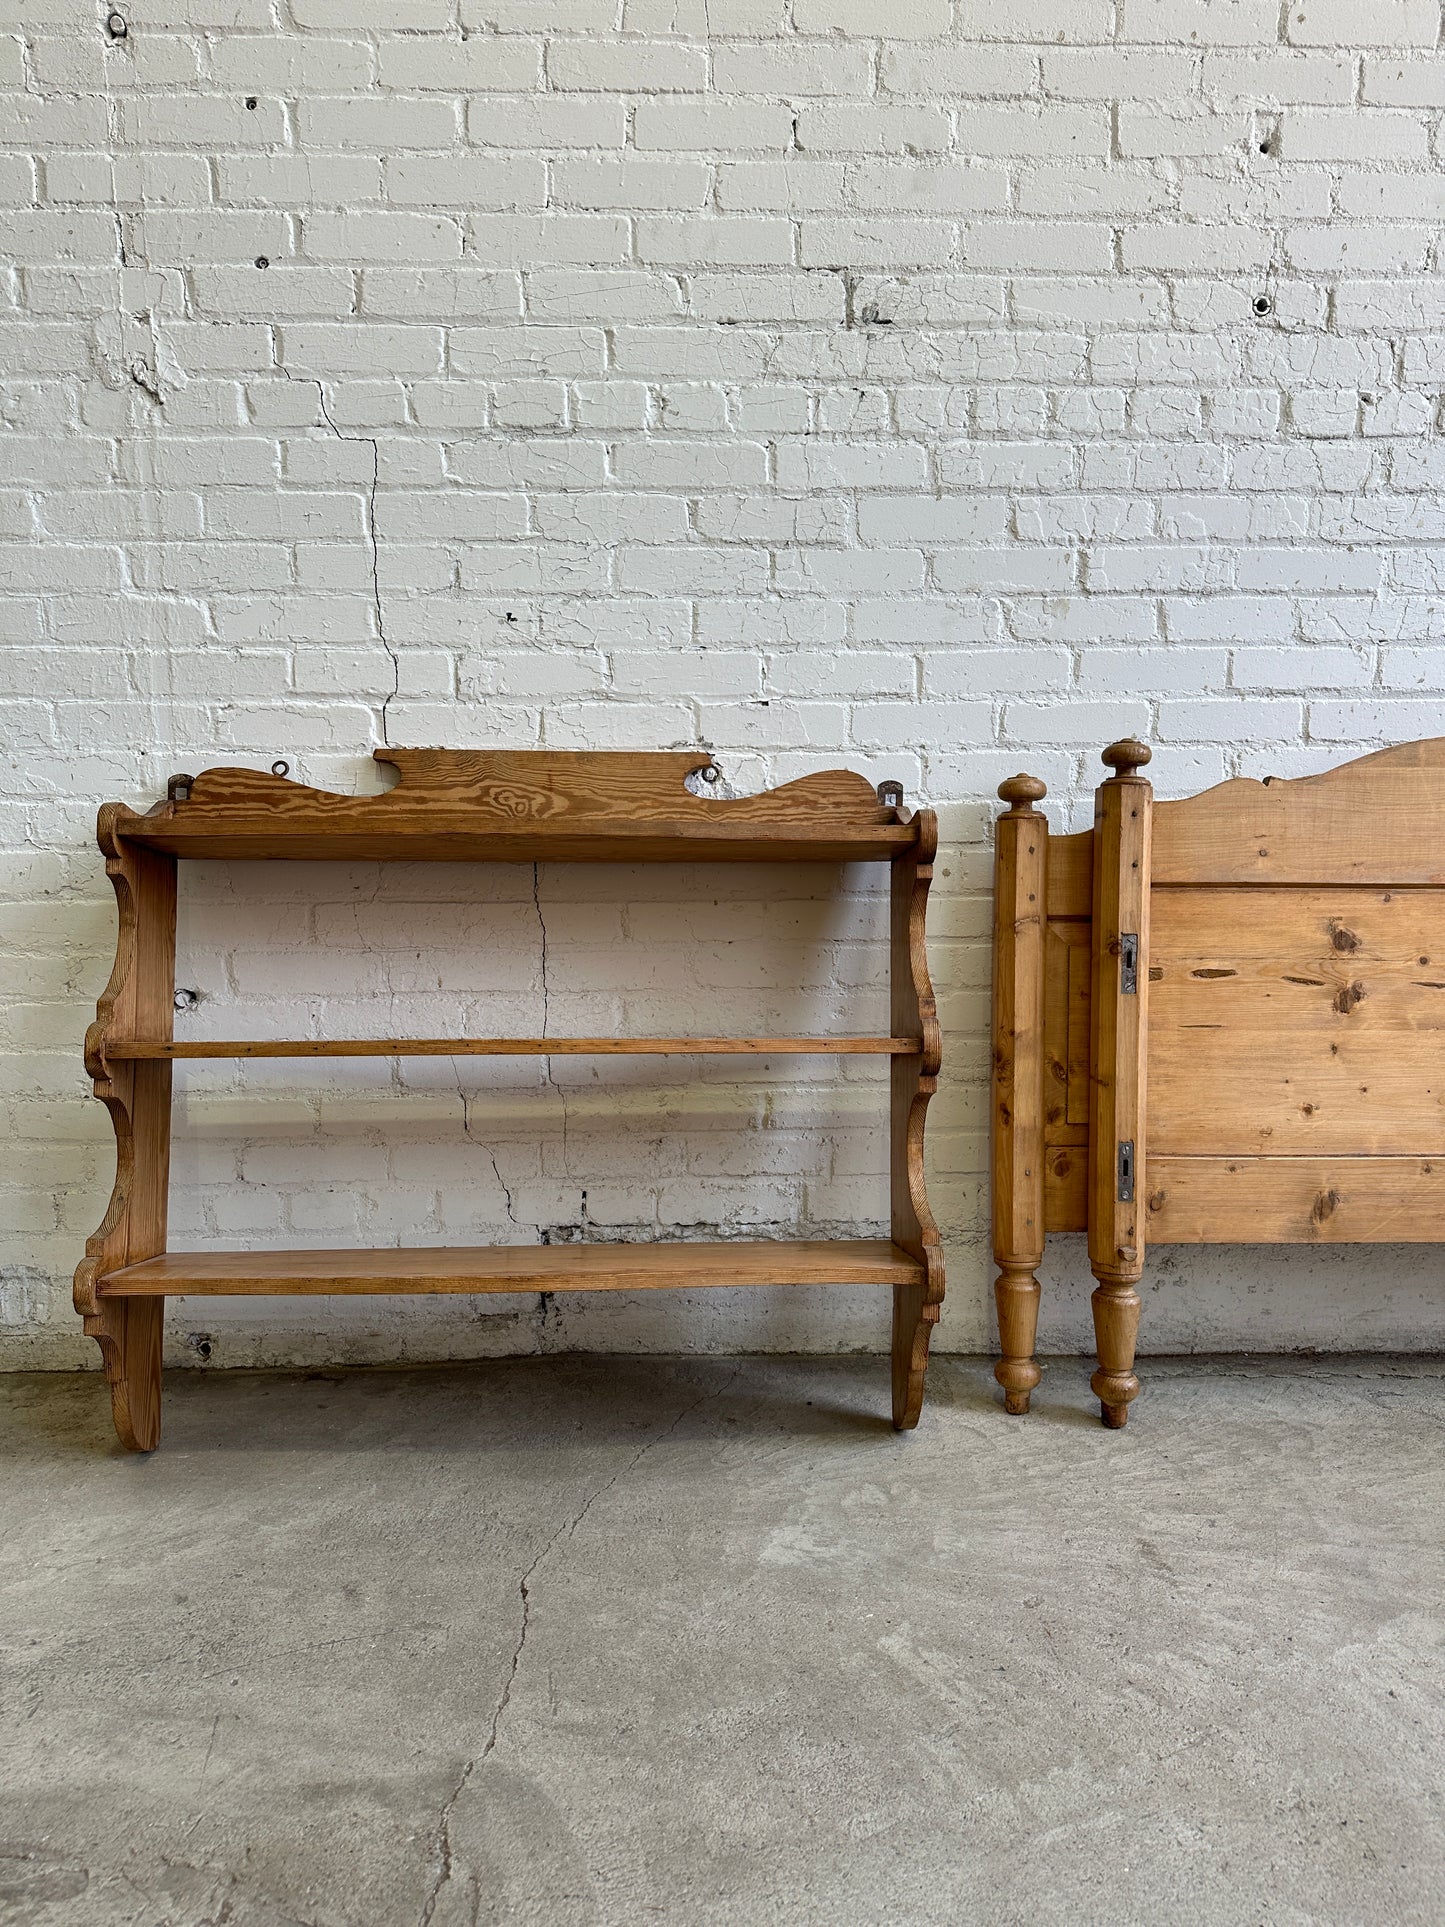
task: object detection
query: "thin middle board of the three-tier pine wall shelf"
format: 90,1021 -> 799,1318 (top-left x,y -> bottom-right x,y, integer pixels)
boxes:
100,1037 -> 923,1064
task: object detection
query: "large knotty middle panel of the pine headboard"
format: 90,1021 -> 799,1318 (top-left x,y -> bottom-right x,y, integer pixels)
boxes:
1148,888 -> 1445,1156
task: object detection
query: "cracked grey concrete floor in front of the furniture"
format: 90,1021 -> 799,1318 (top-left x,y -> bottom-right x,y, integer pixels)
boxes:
0,1357 -> 1445,1927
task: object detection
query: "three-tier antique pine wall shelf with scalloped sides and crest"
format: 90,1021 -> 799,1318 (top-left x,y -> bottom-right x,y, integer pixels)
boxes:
75,750 -> 944,1451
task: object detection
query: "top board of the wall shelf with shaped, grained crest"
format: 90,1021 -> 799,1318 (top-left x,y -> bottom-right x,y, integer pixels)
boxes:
98,750 -> 931,863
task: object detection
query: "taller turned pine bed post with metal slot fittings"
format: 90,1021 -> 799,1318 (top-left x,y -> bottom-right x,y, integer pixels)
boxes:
1089,740 -> 1154,1428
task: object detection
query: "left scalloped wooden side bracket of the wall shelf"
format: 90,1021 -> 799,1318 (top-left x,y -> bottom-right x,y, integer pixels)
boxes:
75,804 -> 175,1451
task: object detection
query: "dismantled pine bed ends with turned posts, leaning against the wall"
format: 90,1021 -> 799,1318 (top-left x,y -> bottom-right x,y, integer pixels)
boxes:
992,738 -> 1445,1426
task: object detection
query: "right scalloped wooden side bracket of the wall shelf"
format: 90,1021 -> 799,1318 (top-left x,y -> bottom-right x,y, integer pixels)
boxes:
890,809 -> 944,1432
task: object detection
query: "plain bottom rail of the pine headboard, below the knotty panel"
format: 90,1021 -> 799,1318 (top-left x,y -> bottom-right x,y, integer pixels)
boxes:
1148,1152 -> 1445,1245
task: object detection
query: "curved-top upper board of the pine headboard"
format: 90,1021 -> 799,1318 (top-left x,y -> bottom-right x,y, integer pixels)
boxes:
1152,738 -> 1445,886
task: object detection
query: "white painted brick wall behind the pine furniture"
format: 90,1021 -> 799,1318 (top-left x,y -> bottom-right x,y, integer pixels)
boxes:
0,0 -> 1445,1364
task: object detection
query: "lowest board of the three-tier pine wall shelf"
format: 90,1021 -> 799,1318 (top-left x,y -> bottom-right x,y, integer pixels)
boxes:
98,1237 -> 923,1299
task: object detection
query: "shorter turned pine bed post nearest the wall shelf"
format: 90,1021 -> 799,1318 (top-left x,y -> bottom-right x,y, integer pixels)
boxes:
992,777 -> 1048,1412
